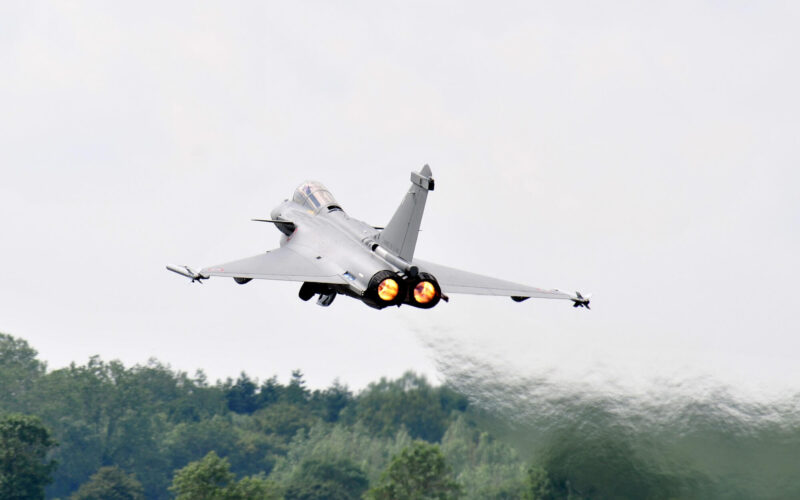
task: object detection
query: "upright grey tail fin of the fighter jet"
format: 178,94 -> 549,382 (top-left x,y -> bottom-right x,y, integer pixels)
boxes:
378,165 -> 433,262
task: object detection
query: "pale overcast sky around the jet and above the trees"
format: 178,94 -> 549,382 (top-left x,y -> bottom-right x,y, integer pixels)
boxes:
0,1 -> 800,394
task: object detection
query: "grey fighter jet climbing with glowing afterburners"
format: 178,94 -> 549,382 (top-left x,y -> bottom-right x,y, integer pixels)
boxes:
167,165 -> 591,309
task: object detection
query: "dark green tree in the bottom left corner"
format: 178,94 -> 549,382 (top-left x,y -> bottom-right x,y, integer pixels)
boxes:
0,414 -> 56,500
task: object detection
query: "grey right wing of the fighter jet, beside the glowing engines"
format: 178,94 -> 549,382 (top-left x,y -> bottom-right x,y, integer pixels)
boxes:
414,259 -> 588,304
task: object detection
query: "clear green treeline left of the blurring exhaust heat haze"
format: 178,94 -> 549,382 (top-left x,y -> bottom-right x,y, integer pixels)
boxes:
0,334 -> 556,500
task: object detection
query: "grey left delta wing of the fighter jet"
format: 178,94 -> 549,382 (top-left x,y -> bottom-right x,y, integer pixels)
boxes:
200,247 -> 347,285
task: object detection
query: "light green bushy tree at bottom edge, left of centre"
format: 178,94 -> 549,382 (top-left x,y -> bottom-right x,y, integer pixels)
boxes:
169,451 -> 281,500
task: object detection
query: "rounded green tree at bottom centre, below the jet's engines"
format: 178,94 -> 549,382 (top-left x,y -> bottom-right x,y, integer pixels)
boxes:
367,441 -> 461,500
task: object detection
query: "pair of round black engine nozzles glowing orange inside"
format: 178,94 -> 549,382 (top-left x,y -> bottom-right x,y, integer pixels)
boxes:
364,271 -> 442,309
